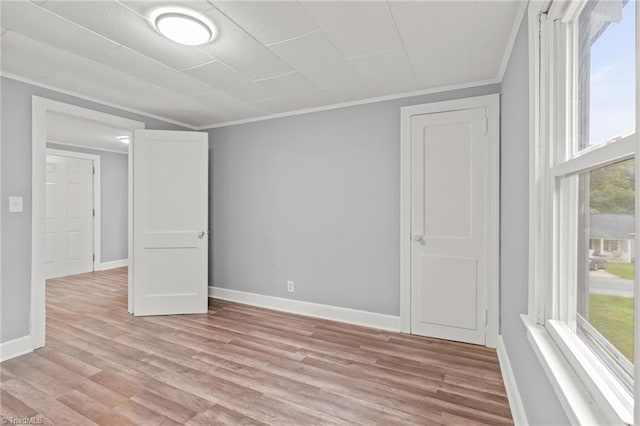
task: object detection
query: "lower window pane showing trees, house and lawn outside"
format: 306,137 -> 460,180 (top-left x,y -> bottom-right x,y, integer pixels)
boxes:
576,161 -> 635,392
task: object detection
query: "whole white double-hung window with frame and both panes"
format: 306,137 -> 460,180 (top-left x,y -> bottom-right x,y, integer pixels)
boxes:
529,0 -> 640,423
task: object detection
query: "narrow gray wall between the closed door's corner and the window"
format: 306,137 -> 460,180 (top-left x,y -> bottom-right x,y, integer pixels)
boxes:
500,11 -> 569,425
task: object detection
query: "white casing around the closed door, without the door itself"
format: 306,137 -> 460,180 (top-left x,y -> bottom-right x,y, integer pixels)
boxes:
400,94 -> 500,348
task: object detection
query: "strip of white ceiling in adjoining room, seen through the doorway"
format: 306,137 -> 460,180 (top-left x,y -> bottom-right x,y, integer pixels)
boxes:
47,113 -> 131,154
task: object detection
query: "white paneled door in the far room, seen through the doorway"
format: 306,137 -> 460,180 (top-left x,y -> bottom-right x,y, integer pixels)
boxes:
45,155 -> 94,279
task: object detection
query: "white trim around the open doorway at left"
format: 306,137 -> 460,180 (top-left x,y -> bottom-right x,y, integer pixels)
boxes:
30,96 -> 145,349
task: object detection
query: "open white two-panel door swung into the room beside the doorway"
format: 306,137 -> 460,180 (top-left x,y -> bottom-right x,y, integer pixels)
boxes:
129,130 -> 209,315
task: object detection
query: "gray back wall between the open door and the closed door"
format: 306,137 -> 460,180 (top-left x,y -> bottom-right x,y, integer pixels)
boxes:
209,85 -> 500,315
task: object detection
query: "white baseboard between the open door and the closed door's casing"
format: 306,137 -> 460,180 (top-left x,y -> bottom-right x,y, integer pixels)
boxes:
209,286 -> 400,331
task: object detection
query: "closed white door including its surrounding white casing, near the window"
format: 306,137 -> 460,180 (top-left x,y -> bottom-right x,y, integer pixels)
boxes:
401,95 -> 499,347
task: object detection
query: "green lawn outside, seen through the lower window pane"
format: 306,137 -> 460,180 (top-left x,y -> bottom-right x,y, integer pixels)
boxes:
589,294 -> 633,362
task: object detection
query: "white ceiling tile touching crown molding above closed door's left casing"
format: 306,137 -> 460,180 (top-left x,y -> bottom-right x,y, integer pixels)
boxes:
350,49 -> 418,96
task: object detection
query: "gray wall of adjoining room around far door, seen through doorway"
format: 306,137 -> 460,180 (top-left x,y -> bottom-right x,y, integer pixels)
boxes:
47,143 -> 129,263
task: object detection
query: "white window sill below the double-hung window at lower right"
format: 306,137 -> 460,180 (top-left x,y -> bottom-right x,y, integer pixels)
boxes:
521,314 -> 633,425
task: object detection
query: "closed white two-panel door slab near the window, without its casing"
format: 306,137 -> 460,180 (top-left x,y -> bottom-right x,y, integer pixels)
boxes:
411,108 -> 489,344
